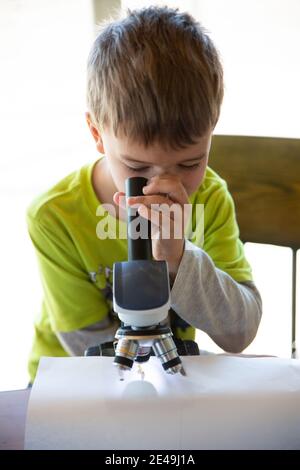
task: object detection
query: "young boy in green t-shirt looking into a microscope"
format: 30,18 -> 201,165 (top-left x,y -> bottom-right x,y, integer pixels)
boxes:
28,7 -> 261,381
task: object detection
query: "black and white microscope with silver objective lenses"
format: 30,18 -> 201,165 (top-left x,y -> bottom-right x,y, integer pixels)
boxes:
113,177 -> 184,374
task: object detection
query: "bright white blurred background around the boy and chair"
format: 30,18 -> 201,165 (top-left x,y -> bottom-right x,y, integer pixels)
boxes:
0,0 -> 300,390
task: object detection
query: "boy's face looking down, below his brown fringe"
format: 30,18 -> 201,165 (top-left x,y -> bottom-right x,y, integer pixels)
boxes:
87,118 -> 212,195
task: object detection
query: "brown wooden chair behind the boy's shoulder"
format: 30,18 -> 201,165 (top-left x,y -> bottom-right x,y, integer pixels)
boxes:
209,135 -> 300,357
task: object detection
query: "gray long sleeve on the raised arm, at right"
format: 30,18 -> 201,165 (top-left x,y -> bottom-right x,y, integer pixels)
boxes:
171,240 -> 262,353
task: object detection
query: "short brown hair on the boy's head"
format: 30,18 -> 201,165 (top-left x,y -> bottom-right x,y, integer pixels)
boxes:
87,7 -> 223,148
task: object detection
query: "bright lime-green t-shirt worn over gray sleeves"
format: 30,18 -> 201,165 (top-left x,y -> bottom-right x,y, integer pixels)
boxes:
27,158 -> 252,381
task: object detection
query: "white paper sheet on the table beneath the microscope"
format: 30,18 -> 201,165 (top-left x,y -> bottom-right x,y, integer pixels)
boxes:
25,355 -> 300,450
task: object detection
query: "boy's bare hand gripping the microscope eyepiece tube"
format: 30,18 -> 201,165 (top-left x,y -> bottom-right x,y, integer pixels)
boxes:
114,175 -> 189,279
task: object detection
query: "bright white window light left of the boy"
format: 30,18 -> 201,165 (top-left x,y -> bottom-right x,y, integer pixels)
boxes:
0,0 -> 97,390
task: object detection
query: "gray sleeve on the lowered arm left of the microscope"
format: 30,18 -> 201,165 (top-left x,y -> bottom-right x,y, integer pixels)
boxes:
56,316 -> 119,356
